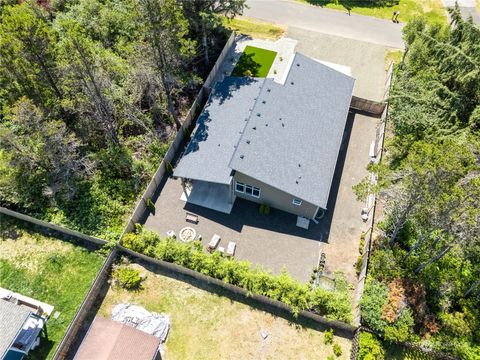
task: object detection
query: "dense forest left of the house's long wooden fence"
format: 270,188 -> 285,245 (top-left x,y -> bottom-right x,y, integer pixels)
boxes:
0,0 -> 245,240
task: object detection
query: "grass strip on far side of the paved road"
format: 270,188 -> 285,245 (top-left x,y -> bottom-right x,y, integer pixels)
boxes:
299,0 -> 447,22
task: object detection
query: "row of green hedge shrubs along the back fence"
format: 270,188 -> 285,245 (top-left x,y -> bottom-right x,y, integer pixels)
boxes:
122,225 -> 352,323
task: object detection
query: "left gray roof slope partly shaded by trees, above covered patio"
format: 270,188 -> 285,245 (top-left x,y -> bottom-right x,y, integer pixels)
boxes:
174,77 -> 264,184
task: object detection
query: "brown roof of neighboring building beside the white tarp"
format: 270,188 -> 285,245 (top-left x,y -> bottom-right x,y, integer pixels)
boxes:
74,316 -> 160,360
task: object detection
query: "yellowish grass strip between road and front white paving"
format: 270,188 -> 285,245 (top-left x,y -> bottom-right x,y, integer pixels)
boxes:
223,17 -> 285,40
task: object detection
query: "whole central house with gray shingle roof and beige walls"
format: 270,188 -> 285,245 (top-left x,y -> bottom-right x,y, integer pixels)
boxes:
173,53 -> 355,219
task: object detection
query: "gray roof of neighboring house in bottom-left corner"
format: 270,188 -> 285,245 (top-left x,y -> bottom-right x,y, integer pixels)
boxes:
0,299 -> 31,359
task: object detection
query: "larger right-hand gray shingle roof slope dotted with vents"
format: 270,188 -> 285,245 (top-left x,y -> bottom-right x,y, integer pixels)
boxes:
230,53 -> 355,208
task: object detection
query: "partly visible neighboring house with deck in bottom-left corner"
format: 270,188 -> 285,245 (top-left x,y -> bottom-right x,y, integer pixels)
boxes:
0,288 -> 53,360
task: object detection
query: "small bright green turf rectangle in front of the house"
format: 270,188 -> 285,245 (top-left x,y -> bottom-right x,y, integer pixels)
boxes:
232,46 -> 277,77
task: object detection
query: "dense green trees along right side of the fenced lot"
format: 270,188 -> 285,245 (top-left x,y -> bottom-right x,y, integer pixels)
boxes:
354,8 -> 480,359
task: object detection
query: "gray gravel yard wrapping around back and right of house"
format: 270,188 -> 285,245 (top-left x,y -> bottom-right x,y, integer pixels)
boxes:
145,110 -> 378,283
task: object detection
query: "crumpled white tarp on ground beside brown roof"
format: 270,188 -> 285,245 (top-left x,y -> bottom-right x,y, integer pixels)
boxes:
112,304 -> 171,343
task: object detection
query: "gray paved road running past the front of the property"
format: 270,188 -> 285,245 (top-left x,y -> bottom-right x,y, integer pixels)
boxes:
244,0 -> 404,49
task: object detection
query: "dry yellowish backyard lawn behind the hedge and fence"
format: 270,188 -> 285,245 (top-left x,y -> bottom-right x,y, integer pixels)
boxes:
99,264 -> 351,360
